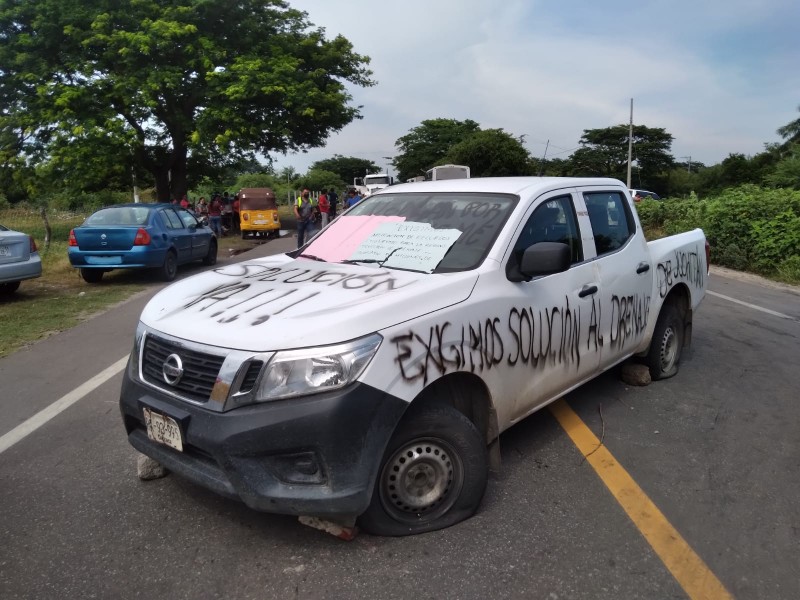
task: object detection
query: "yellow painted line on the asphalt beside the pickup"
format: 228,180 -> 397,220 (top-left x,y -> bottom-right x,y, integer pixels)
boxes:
550,400 -> 733,600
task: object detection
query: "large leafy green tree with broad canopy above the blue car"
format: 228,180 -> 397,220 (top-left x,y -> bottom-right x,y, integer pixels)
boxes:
0,0 -> 374,199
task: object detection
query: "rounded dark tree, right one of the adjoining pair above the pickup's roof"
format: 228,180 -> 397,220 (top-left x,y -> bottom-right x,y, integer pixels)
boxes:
444,129 -> 531,177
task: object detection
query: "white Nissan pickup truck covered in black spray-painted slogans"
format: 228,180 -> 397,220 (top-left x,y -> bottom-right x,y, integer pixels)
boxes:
120,177 -> 708,535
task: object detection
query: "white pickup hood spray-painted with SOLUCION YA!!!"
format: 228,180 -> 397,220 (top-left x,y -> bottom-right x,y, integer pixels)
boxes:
141,255 -> 478,352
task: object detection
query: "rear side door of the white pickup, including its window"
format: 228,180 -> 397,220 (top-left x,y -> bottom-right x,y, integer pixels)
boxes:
579,187 -> 653,370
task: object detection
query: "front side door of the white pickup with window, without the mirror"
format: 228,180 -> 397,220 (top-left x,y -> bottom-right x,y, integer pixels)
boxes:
506,191 -> 601,420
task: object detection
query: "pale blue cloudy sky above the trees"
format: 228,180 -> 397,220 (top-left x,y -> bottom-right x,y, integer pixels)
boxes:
273,0 -> 800,174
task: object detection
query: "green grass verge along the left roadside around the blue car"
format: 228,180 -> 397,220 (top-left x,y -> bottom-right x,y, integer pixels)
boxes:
0,208 -> 253,358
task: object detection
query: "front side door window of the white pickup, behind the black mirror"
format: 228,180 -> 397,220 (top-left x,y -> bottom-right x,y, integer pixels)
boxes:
511,194 -> 583,272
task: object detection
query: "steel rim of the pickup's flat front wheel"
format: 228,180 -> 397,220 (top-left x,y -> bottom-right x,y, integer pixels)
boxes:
380,438 -> 464,523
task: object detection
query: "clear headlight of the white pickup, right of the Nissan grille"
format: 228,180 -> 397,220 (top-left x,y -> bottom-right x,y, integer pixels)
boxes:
256,333 -> 383,402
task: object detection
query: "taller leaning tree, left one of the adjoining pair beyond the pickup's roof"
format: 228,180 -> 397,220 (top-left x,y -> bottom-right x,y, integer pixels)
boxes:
394,119 -> 480,181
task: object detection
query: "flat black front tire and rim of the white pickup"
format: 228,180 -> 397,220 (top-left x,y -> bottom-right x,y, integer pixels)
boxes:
359,403 -> 489,536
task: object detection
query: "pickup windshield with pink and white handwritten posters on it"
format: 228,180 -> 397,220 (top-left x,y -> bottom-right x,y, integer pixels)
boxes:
302,193 -> 519,273
